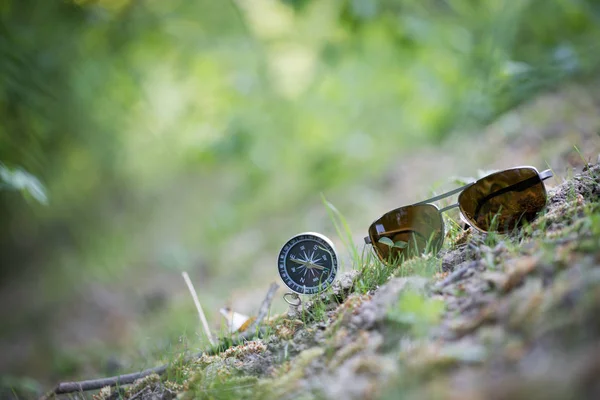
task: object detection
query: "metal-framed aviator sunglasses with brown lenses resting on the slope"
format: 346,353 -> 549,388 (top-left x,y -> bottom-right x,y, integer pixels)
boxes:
365,167 -> 553,264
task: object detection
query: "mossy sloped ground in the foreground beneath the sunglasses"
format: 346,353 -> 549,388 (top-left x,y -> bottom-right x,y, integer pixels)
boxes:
79,165 -> 600,399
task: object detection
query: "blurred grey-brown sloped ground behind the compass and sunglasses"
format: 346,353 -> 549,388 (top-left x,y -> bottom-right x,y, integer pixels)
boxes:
0,78 -> 600,397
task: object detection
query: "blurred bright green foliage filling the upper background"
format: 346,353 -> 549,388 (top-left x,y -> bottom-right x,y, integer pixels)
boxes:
0,0 -> 600,382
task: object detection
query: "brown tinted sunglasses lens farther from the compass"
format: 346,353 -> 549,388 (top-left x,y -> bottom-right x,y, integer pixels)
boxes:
458,168 -> 546,233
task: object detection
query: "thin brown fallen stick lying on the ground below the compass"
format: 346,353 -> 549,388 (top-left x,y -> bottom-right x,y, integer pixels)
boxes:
40,283 -> 279,400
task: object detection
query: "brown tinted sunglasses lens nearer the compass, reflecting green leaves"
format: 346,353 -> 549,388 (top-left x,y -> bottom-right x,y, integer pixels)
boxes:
369,204 -> 444,263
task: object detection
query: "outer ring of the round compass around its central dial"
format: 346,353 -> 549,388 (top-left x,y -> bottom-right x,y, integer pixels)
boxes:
277,232 -> 338,294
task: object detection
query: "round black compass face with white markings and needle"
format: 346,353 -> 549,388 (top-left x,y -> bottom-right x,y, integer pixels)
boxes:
278,232 -> 337,294
